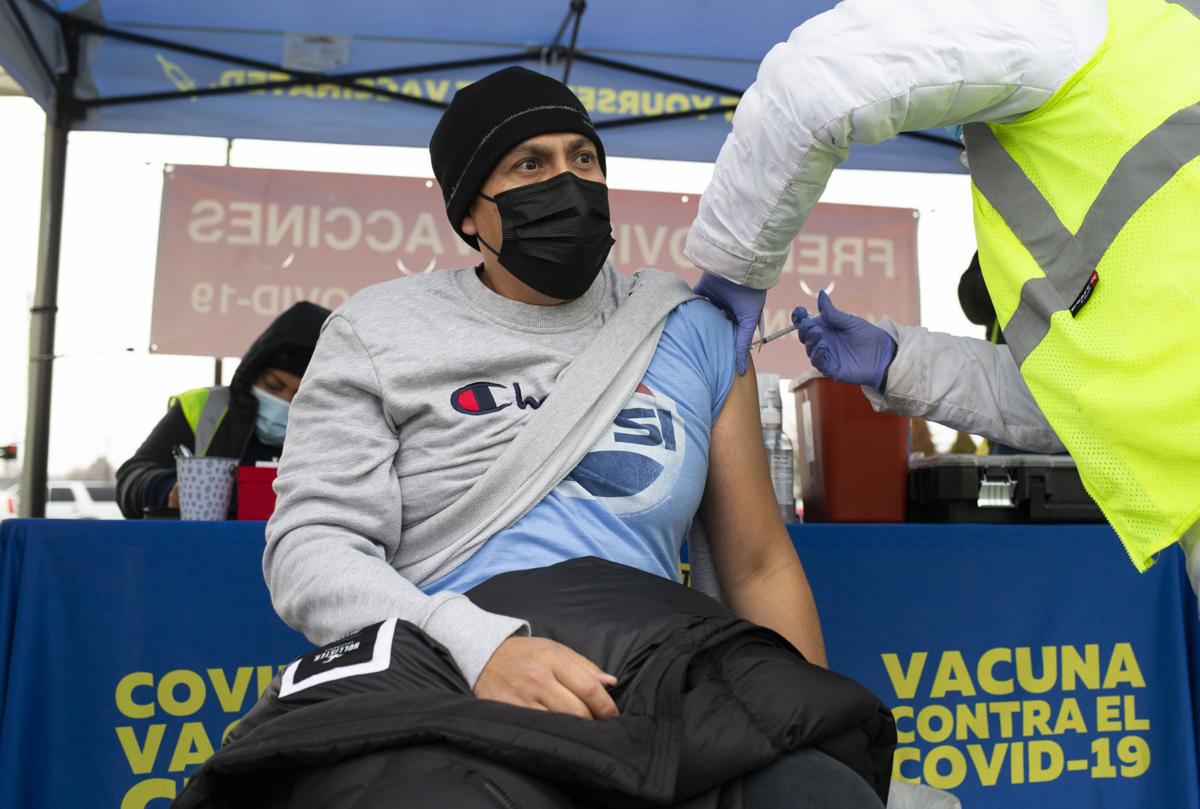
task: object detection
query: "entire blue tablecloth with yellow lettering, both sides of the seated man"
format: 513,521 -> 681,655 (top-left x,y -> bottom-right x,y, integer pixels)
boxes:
0,520 -> 1200,809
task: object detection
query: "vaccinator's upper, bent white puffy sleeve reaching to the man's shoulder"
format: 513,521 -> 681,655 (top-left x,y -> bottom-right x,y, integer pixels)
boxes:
686,0 -> 1108,289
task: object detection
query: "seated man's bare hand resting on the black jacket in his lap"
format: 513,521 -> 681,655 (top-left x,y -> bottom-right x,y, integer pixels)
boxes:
475,637 -> 618,719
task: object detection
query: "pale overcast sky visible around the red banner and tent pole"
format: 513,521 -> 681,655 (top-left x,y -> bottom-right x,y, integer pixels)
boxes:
0,98 -> 982,477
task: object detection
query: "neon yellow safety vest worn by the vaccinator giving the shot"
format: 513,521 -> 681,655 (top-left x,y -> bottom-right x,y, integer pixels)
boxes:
966,0 -> 1200,570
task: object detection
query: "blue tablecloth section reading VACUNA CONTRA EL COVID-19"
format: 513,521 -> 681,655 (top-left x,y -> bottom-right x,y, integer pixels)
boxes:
792,525 -> 1200,809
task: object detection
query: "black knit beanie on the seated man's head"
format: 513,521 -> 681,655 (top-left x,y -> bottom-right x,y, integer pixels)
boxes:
430,67 -> 607,250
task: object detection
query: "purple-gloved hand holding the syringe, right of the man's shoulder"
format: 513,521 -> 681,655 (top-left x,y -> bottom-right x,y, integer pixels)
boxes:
792,290 -> 896,388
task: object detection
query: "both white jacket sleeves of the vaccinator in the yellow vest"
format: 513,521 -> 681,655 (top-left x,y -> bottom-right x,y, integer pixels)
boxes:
686,0 -> 1108,451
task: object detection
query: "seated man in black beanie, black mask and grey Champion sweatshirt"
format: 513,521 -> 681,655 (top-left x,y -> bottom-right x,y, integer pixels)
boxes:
263,67 -> 878,805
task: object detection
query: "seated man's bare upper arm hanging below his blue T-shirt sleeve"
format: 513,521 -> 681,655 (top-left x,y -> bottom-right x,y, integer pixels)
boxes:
701,355 -> 826,666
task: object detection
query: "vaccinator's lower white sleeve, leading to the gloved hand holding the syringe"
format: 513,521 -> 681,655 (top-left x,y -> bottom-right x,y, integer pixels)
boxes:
863,319 -> 1063,453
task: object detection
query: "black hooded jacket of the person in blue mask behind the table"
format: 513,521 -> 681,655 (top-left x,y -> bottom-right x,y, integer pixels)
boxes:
116,301 -> 330,520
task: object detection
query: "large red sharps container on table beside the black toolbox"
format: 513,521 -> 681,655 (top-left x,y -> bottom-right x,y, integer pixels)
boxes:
792,371 -> 908,522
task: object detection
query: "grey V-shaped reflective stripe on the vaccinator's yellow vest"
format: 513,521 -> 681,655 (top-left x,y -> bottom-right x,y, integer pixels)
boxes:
964,101 -> 1200,365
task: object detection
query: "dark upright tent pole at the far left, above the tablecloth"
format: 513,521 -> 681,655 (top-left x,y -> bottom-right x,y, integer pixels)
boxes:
20,110 -> 71,517
